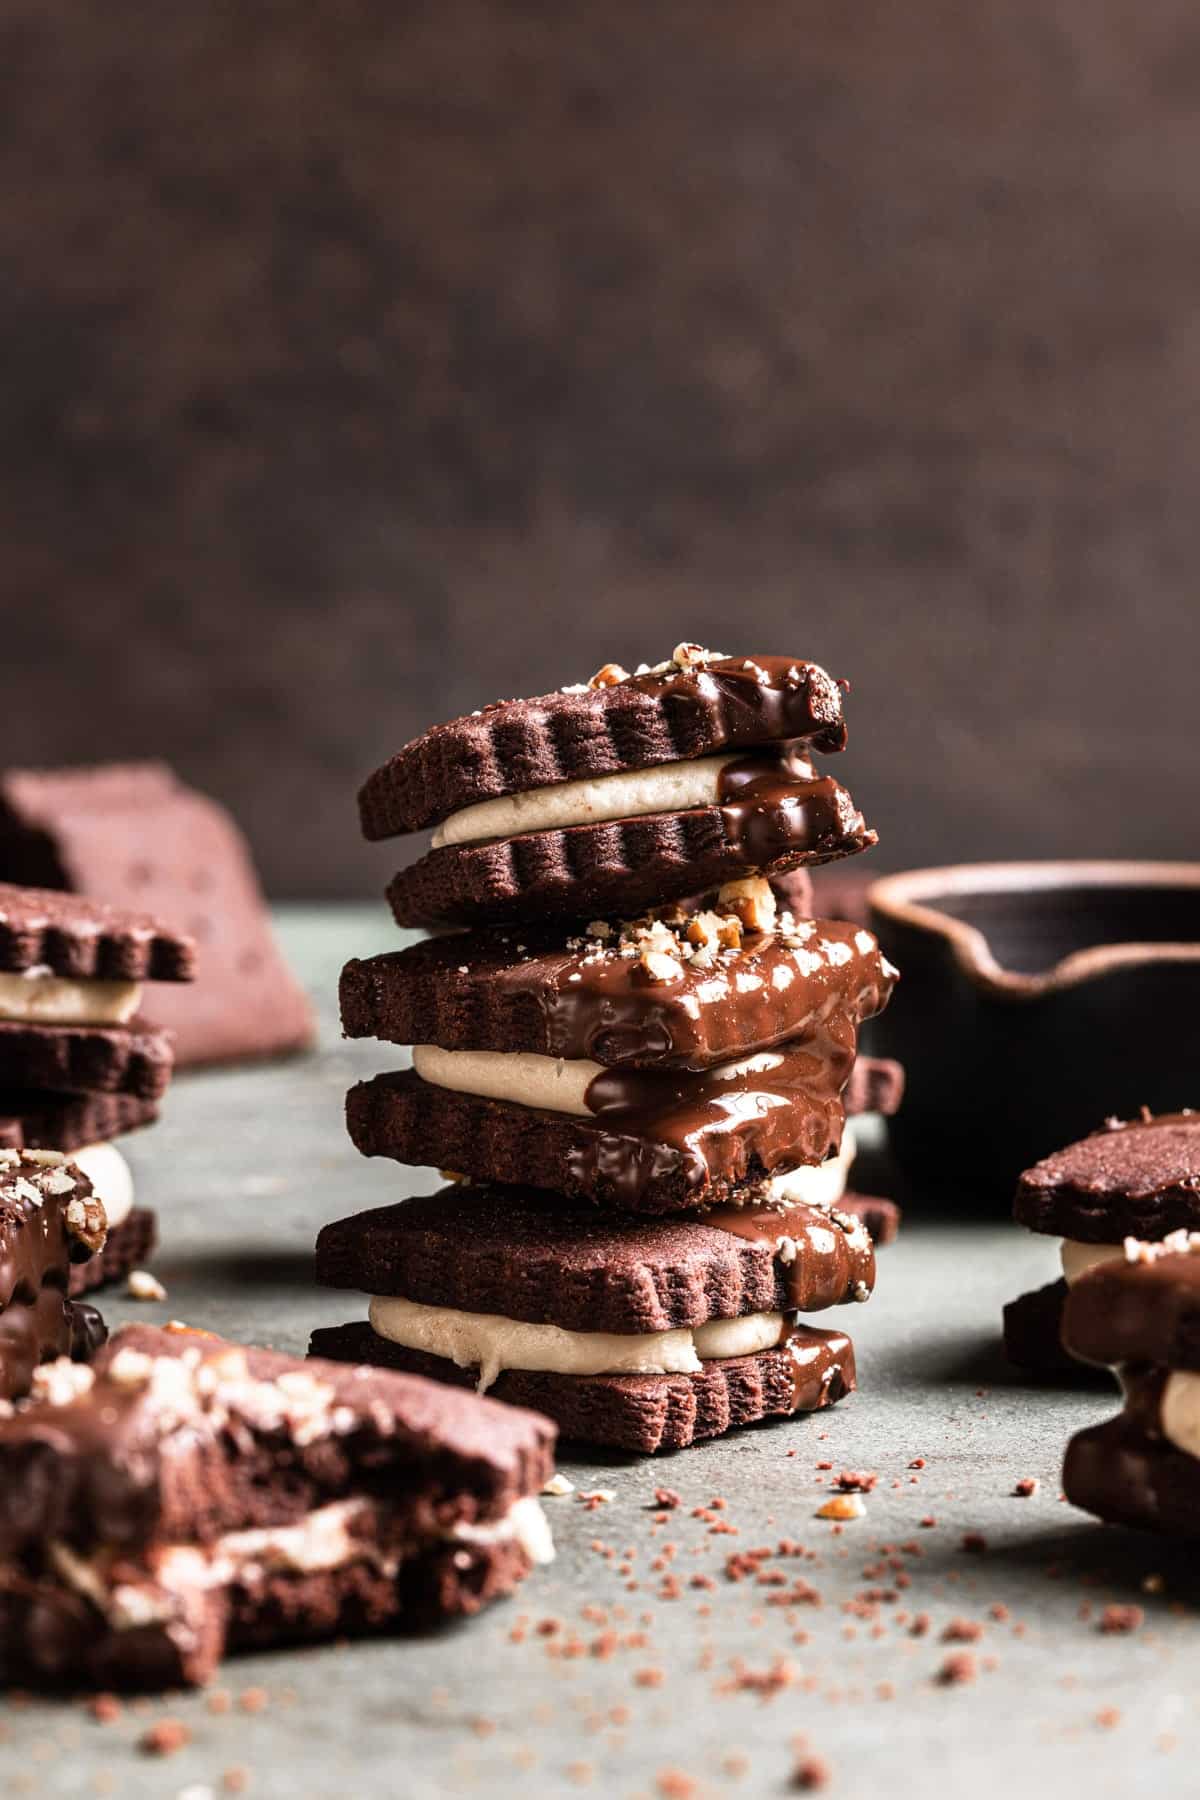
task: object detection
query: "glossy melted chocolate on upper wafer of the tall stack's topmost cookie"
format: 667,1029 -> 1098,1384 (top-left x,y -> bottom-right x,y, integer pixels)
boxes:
622,657 -> 846,752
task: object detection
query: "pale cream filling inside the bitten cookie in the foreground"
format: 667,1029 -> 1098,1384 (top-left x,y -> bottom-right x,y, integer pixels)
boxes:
47,1494 -> 554,1631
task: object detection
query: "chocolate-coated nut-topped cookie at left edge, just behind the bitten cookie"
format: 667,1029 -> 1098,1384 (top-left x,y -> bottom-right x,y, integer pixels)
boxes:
0,1150 -> 104,1400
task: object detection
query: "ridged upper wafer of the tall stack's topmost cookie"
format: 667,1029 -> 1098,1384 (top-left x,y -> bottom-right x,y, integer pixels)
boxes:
358,657 -> 846,839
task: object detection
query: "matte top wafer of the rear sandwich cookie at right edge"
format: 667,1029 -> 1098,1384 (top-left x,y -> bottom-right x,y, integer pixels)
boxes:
1013,1112 -> 1200,1244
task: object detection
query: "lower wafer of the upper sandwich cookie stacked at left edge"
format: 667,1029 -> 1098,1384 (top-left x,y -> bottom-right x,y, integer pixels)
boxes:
0,1019 -> 175,1100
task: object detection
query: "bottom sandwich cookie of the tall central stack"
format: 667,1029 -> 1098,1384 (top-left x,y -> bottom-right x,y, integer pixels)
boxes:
313,1186 -> 874,1453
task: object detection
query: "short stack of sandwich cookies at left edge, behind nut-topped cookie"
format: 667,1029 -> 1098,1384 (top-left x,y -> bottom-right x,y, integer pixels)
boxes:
0,886 -> 194,1294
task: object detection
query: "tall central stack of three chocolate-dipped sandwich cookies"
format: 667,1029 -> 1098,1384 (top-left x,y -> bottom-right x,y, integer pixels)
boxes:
311,644 -> 900,1451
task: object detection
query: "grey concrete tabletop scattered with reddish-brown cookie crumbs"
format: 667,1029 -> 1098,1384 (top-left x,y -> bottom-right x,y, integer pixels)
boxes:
0,907 -> 1200,1800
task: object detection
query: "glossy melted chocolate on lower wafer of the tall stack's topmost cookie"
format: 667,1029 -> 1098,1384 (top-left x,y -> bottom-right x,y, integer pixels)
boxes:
718,743 -> 865,869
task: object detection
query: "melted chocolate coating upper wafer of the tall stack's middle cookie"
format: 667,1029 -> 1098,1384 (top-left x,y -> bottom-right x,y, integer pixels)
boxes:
539,920 -> 896,1069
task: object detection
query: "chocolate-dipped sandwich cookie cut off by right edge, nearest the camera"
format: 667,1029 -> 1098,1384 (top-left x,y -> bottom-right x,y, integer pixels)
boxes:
1063,1229 -> 1200,1537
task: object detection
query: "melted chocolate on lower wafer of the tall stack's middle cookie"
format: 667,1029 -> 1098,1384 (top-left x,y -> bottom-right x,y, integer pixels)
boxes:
572,1012 -> 858,1208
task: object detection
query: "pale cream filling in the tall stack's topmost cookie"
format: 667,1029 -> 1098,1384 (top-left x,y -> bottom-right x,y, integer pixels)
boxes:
434,756 -> 736,850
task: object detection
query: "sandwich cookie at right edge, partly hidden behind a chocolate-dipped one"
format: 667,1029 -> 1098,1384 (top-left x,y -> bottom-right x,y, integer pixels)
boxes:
1004,1112 -> 1200,1379
